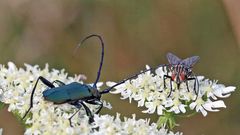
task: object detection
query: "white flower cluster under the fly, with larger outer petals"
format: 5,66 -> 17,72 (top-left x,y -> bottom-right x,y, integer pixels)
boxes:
107,66 -> 235,116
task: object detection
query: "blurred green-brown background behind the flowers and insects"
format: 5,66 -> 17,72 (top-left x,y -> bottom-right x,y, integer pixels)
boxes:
0,0 -> 240,135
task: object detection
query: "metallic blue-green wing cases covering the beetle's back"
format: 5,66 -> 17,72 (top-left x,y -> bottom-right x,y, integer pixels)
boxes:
43,82 -> 92,104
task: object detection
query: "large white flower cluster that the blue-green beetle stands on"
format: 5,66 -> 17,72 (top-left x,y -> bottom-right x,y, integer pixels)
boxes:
0,62 -> 181,135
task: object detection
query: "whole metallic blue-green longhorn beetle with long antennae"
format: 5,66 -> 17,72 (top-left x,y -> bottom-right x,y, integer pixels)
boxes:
22,34 -> 154,126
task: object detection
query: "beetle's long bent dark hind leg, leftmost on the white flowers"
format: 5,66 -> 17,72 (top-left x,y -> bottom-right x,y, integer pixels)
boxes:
22,76 -> 55,119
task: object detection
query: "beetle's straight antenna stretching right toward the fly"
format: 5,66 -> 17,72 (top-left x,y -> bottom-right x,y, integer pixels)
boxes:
100,64 -> 168,94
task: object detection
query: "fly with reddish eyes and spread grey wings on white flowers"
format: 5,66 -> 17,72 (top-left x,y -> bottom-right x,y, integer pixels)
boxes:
163,53 -> 200,96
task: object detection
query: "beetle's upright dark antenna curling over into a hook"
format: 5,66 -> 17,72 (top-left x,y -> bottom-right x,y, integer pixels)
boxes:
74,34 -> 104,88
